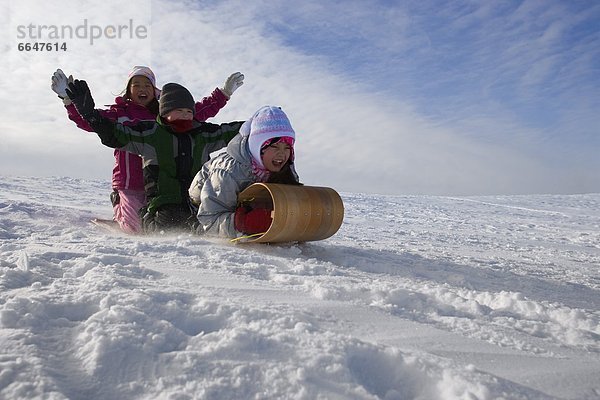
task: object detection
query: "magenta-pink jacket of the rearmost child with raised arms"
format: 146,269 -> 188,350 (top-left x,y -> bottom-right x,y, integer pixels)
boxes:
65,88 -> 228,191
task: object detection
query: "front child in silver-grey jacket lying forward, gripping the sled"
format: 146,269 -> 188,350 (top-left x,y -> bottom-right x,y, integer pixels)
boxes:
189,106 -> 300,238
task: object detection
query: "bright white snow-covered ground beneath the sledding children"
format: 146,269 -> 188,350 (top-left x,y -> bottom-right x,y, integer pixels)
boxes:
0,176 -> 600,400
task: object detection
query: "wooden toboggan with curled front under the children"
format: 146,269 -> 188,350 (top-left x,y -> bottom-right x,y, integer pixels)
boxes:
238,183 -> 344,243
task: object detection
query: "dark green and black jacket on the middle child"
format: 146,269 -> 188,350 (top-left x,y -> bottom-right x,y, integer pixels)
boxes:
92,117 -> 244,215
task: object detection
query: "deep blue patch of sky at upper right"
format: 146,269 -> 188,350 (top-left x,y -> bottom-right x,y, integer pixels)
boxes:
270,1 -> 600,132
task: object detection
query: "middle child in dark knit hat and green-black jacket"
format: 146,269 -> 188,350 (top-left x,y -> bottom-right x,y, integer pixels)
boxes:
66,80 -> 243,233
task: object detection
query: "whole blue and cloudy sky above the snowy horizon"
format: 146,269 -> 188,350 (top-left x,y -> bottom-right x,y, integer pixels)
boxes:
0,0 -> 600,195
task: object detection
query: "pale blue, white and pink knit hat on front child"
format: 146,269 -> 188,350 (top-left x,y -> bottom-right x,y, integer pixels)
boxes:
247,106 -> 296,168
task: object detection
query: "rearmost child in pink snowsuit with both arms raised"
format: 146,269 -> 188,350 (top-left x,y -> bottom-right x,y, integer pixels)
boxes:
52,66 -> 244,234
